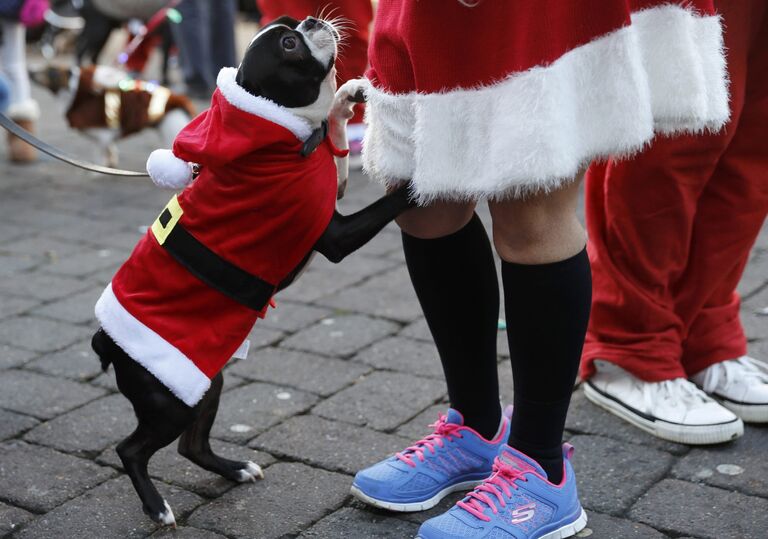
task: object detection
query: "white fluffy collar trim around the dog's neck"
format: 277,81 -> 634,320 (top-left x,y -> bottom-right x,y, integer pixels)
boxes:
216,67 -> 312,140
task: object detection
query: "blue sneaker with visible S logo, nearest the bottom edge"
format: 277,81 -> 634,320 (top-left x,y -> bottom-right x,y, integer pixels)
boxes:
417,444 -> 587,539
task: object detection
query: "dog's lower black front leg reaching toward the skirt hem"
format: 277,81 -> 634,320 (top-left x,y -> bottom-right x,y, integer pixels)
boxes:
314,184 -> 416,263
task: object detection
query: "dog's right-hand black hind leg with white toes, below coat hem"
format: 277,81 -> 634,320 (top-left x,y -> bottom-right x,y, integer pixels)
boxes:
179,373 -> 264,483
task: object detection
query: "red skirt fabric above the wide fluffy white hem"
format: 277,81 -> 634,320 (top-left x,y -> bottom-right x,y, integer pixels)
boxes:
366,0 -> 715,94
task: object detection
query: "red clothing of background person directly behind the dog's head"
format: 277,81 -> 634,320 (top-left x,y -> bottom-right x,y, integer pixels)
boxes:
258,0 -> 373,123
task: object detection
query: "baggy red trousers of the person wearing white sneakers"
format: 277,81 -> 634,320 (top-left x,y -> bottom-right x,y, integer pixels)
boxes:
582,0 -> 768,382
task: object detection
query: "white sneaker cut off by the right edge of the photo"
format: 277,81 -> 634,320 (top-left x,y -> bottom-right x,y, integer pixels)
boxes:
691,356 -> 768,423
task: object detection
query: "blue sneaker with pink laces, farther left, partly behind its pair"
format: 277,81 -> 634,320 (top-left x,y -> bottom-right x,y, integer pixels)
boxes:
351,408 -> 509,511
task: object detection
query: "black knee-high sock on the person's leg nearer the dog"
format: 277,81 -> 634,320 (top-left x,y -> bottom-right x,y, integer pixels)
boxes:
403,214 -> 501,438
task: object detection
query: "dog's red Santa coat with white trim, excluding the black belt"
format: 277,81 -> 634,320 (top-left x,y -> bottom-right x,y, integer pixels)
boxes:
96,68 -> 337,406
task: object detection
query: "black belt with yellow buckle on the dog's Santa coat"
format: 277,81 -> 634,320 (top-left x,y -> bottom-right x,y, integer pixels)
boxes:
152,195 -> 275,311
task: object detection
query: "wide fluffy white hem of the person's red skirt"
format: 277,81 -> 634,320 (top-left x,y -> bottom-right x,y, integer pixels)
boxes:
363,5 -> 729,203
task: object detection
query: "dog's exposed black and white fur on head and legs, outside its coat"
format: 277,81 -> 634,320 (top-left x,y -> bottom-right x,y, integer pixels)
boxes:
92,18 -> 411,525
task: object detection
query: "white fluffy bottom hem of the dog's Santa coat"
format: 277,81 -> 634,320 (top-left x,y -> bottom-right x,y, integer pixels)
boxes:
95,283 -> 211,406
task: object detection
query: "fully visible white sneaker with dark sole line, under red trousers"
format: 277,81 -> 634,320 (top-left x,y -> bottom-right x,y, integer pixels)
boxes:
584,366 -> 744,445
